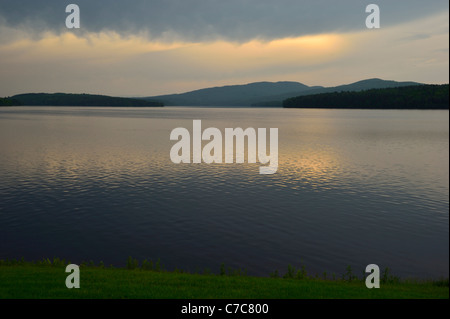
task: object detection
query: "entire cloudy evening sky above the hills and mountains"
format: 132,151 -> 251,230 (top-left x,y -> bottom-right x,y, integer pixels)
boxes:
0,0 -> 449,97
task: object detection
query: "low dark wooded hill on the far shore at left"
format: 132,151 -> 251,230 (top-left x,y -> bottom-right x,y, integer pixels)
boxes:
11,93 -> 164,106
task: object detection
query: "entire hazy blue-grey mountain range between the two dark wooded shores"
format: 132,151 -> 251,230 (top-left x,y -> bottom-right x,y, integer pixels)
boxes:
143,79 -> 421,106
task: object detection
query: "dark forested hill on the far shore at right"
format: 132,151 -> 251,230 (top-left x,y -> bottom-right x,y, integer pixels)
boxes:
283,84 -> 449,110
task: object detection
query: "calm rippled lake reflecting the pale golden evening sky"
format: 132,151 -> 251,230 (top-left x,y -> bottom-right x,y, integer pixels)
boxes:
0,107 -> 449,278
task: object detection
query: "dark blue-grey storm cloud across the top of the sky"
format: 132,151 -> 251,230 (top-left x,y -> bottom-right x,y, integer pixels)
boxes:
0,0 -> 448,41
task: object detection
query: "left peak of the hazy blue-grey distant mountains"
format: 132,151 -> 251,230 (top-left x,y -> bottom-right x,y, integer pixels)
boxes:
144,82 -> 319,106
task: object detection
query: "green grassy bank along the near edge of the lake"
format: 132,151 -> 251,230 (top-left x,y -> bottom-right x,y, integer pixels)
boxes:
0,260 -> 449,299
